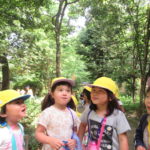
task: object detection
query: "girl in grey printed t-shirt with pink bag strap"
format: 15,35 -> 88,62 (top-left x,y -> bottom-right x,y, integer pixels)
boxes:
78,77 -> 130,150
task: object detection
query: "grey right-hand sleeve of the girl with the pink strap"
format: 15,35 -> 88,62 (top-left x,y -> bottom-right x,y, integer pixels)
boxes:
116,111 -> 131,134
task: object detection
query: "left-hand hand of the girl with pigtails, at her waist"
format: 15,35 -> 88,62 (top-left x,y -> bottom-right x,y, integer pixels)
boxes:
49,137 -> 64,150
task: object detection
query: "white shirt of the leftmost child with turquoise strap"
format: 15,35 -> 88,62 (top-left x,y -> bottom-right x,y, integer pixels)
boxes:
0,123 -> 24,150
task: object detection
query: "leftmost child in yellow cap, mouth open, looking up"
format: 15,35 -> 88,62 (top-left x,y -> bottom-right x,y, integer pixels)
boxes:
0,90 -> 30,150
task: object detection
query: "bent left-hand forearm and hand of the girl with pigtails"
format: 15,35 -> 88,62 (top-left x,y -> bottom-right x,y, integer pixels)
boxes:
35,125 -> 64,149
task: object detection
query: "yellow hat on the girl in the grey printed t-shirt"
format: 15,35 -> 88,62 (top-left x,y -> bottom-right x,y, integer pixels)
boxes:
89,77 -> 119,98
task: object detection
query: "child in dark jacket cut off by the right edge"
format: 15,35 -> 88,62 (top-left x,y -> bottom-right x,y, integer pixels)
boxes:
135,87 -> 150,150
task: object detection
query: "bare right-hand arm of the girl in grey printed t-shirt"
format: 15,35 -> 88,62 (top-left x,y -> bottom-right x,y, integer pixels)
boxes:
118,133 -> 129,150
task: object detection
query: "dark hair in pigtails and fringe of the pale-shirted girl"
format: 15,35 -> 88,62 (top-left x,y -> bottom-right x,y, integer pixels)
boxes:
41,81 -> 76,111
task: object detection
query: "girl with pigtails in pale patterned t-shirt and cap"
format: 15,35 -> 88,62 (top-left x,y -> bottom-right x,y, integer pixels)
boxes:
35,77 -> 80,150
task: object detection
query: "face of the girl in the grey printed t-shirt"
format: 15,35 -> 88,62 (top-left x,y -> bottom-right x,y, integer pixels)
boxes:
91,87 -> 108,105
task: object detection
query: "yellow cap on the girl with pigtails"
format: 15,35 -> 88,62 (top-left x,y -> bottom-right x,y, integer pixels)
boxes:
51,77 -> 75,87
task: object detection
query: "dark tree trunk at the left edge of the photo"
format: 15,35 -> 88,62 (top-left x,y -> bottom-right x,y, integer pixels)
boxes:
0,56 -> 9,90
